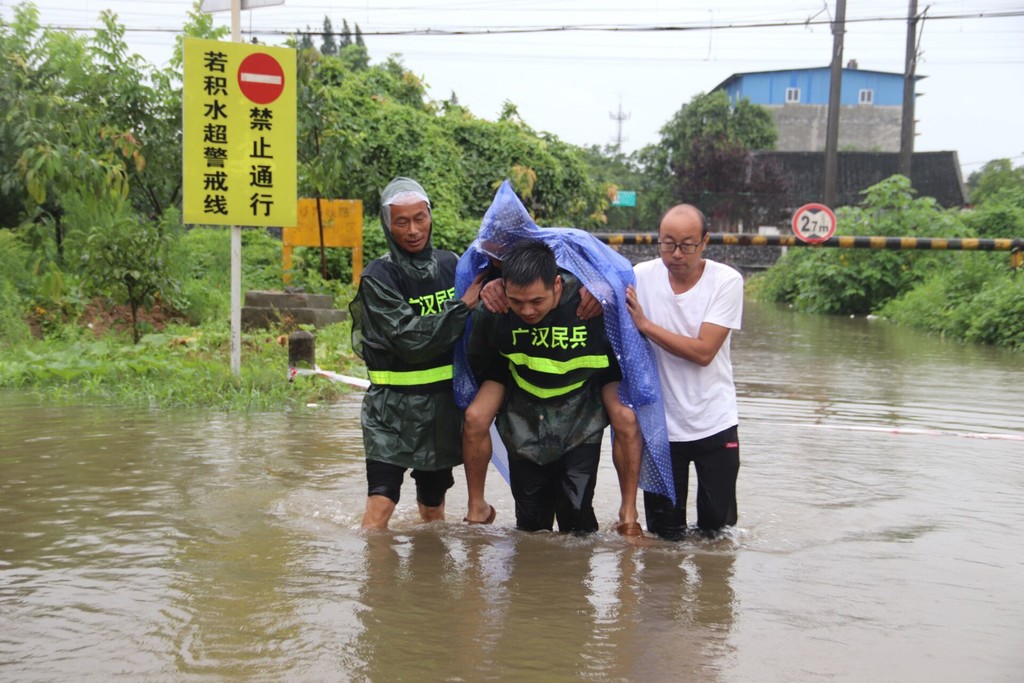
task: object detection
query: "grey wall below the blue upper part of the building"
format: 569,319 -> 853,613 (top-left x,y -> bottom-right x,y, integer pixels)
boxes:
767,104 -> 902,152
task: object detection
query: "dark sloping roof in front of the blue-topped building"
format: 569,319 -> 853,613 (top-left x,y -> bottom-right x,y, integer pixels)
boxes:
753,151 -> 968,208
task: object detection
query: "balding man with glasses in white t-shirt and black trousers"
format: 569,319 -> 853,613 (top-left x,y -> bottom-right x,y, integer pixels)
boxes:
626,204 -> 743,540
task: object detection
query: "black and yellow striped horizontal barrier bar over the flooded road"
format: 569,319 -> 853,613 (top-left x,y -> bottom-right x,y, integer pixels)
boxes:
597,232 -> 1024,268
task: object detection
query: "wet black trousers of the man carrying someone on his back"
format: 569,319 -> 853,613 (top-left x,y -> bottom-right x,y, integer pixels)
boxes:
509,443 -> 601,536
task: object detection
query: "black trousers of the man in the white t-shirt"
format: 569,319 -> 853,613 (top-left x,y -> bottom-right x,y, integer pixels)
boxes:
643,426 -> 739,541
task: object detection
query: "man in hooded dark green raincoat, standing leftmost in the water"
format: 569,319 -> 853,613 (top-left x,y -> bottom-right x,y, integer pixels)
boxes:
349,177 -> 482,528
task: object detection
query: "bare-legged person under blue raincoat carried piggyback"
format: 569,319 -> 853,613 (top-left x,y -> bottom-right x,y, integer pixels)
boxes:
456,180 -> 674,536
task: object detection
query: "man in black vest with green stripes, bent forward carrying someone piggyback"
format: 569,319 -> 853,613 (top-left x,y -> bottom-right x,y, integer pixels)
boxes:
468,240 -> 621,535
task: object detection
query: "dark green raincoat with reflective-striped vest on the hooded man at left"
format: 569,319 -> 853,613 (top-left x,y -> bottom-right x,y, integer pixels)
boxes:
349,181 -> 470,470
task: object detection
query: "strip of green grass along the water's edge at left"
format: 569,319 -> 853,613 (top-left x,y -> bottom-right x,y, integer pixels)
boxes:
0,323 -> 366,411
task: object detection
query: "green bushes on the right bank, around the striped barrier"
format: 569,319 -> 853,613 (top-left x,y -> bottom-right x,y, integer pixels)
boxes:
751,167 -> 1024,351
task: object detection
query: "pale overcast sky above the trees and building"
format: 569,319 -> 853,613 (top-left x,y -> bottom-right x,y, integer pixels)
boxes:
6,0 -> 1024,180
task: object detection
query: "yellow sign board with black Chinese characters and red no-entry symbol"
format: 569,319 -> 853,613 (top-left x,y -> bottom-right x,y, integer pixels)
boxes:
182,38 -> 296,226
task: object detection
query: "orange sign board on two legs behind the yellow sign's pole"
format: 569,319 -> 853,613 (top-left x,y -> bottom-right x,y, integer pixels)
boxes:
281,198 -> 362,284
